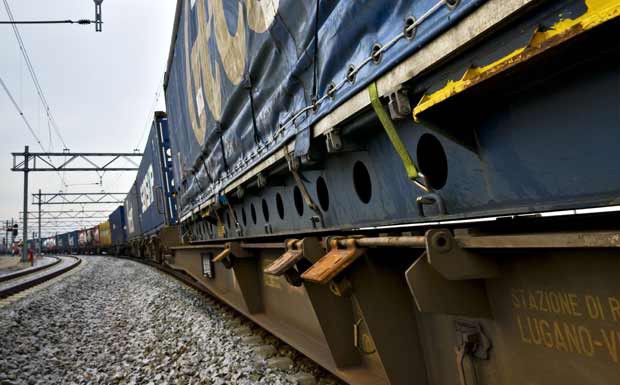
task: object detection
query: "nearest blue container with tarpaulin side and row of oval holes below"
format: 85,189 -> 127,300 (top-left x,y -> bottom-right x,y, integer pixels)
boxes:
165,0 -> 620,241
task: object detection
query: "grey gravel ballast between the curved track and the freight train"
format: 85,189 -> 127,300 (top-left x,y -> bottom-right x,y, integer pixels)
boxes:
0,257 -> 339,385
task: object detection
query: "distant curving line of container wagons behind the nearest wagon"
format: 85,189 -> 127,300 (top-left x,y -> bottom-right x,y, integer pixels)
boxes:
41,111 -> 179,261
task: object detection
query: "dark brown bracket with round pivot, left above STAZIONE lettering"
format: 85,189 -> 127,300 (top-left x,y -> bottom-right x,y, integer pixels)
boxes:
426,229 -> 499,280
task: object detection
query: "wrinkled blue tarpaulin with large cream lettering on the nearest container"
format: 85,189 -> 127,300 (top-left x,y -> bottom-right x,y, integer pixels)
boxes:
165,0 -> 484,213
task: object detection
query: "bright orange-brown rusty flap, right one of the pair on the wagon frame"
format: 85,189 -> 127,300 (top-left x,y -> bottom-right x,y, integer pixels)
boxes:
301,239 -> 366,285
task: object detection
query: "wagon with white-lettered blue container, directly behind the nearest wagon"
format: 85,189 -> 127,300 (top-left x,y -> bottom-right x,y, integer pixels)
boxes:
125,111 -> 178,262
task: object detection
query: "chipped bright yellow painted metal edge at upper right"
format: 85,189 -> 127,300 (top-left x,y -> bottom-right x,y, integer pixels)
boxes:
413,0 -> 620,122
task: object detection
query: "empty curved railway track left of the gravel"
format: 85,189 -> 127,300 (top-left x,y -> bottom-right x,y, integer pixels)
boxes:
0,256 -> 82,298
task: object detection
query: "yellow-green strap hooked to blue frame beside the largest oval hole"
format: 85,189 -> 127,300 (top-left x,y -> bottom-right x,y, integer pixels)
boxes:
368,82 -> 429,191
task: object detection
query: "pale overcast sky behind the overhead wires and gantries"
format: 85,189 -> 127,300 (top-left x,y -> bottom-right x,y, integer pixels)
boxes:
0,0 -> 176,240
